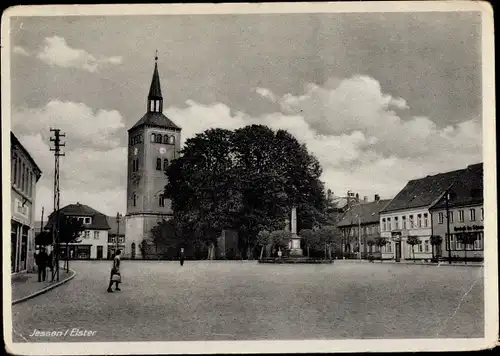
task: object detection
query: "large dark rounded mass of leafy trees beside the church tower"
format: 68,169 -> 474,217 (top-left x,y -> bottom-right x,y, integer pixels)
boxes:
165,125 -> 325,257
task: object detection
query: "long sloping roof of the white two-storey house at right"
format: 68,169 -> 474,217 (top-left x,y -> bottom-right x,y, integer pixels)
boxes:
381,165 -> 477,213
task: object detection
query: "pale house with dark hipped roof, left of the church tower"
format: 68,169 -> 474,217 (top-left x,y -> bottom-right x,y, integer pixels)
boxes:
46,203 -> 109,260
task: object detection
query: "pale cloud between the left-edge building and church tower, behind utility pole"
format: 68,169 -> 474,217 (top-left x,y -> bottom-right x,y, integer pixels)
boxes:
12,100 -> 127,214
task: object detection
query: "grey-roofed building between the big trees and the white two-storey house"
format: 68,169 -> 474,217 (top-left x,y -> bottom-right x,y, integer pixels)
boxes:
337,194 -> 390,258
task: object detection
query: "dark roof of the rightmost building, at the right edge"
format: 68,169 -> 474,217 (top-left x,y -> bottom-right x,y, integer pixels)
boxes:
431,163 -> 484,209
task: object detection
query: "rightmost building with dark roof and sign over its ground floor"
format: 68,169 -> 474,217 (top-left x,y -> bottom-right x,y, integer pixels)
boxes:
429,163 -> 484,259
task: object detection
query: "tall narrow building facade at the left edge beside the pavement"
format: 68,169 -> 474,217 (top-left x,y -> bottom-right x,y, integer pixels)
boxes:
10,132 -> 42,273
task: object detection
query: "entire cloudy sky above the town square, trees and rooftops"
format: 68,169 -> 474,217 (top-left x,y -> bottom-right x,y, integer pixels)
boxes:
11,13 -> 482,216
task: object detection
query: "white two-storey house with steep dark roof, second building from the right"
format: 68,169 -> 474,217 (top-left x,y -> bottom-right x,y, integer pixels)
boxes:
380,164 -> 478,261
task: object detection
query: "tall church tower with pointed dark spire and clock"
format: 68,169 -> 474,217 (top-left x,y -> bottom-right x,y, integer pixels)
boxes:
124,56 -> 181,259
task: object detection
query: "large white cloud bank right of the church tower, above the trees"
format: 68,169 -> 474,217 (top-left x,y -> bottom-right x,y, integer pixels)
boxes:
169,76 -> 482,203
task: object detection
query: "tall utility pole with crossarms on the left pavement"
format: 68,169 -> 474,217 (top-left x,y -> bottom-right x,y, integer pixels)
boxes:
50,129 -> 66,281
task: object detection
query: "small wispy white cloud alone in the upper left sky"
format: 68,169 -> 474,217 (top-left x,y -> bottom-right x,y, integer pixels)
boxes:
37,36 -> 122,72
